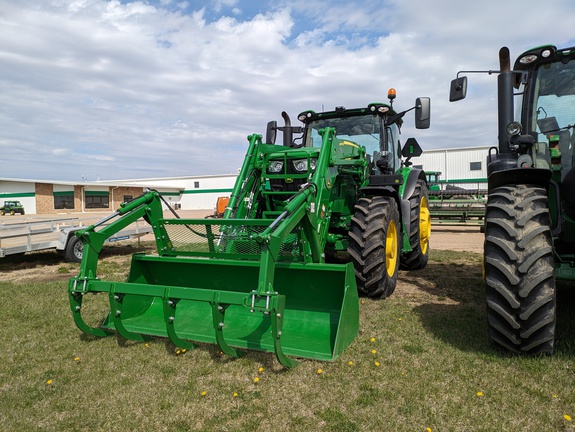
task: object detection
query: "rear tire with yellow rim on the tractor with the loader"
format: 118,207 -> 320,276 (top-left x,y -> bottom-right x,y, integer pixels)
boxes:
399,180 -> 431,270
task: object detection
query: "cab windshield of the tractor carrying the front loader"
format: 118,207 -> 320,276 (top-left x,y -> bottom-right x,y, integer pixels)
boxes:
306,114 -> 381,155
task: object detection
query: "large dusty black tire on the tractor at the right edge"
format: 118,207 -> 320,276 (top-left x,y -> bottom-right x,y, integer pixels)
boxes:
484,185 -> 556,354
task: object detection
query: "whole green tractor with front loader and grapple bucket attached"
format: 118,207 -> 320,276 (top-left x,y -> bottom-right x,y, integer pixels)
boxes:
69,89 -> 430,367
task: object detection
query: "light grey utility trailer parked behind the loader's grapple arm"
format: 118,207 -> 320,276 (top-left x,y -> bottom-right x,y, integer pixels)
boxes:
0,218 -> 152,262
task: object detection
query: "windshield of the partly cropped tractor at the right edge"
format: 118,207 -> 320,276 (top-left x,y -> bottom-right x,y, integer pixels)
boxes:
529,61 -> 575,141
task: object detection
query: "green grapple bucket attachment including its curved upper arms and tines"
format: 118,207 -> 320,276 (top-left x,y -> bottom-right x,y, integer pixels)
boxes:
68,189 -> 359,367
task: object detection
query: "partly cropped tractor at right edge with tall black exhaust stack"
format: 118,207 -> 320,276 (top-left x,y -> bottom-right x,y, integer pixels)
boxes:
450,45 -> 575,354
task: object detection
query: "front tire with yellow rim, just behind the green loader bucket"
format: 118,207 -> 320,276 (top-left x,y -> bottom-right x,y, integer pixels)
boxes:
348,196 -> 401,298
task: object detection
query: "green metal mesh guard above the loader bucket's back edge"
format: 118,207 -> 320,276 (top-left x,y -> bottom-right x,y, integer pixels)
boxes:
160,219 -> 303,261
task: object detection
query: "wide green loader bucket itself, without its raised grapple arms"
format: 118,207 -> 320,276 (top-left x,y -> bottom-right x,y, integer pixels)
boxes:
72,254 -> 359,366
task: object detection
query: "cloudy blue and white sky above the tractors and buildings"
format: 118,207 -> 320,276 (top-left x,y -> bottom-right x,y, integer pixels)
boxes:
0,0 -> 575,181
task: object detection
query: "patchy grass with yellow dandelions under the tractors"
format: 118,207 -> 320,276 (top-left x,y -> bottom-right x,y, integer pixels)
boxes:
0,246 -> 575,432
